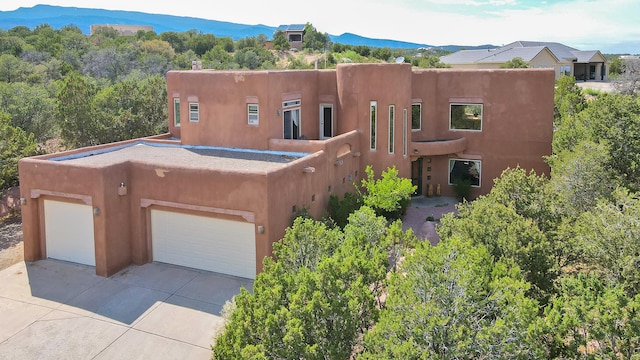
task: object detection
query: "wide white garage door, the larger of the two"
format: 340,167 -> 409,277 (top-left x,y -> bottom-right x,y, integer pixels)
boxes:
151,210 -> 256,279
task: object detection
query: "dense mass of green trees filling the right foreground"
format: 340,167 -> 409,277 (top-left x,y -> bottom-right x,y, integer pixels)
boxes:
213,76 -> 640,359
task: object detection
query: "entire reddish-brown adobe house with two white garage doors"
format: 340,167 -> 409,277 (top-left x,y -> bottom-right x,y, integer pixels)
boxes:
19,64 -> 554,278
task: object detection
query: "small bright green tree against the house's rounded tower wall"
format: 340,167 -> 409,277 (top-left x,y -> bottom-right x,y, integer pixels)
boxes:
362,165 -> 416,219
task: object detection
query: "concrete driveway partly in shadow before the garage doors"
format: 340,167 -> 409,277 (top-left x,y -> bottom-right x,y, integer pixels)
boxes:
0,259 -> 253,359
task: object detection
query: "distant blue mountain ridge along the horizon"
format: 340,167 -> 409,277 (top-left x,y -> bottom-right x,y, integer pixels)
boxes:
0,5 -> 494,51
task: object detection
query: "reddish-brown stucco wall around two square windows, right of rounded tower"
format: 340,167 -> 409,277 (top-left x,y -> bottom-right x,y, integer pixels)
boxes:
412,69 -> 554,196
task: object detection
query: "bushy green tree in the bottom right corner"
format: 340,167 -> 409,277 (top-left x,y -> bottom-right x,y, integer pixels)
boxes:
536,274 -> 640,359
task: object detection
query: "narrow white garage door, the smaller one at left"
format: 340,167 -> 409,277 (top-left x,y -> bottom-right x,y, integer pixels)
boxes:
44,200 -> 96,266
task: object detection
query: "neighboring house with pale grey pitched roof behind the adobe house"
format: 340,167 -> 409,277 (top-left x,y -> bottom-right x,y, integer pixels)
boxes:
440,41 -> 609,81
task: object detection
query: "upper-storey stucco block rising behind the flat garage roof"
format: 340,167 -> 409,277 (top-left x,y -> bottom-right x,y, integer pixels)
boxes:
167,71 -> 337,149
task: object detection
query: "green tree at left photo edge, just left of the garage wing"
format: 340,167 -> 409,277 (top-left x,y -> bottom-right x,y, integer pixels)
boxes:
0,111 -> 38,190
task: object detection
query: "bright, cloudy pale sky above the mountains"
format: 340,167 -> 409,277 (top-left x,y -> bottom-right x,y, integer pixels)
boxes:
0,0 -> 640,54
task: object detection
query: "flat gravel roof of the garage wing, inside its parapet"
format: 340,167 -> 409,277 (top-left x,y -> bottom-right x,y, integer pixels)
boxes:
49,142 -> 309,171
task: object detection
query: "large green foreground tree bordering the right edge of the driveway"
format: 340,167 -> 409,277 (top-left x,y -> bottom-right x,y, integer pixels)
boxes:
213,208 -> 387,359
